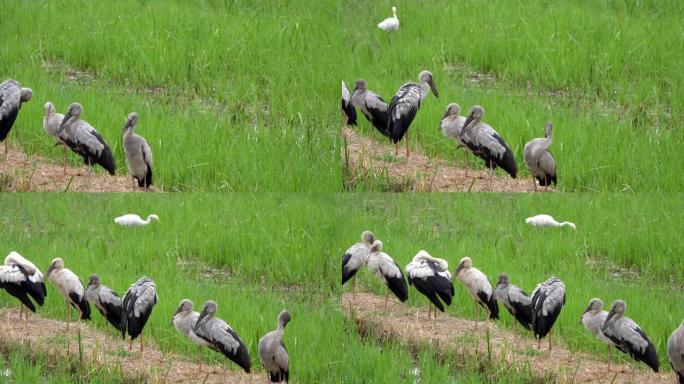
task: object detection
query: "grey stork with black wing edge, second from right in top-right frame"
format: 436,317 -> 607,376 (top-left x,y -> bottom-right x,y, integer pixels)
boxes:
461,105 -> 518,179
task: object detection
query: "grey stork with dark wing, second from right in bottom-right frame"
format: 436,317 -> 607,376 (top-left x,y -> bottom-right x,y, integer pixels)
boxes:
601,300 -> 659,372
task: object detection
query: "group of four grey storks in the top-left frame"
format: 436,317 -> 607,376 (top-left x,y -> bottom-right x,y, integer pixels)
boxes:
0,80 -> 152,190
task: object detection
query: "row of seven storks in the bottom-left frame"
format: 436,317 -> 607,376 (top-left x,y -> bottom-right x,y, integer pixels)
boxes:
0,250 -> 290,383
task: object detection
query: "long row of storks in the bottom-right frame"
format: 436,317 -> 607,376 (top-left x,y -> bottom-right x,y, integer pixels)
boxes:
342,230 -> 684,384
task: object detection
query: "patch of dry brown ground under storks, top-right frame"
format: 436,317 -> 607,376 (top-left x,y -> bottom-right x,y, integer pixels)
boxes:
342,127 -> 554,192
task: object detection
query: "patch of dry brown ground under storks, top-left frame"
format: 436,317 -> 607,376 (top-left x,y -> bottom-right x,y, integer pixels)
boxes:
0,144 -> 154,192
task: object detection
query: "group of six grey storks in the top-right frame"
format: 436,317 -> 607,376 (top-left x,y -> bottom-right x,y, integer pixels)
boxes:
342,71 -> 558,190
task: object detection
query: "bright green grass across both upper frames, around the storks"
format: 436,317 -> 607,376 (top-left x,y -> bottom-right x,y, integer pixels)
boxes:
0,0 -> 684,192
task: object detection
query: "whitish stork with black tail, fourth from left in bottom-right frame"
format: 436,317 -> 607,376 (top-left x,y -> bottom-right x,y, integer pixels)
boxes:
454,257 -> 499,329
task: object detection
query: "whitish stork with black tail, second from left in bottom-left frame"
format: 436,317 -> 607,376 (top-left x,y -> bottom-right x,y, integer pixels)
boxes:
46,257 -> 90,331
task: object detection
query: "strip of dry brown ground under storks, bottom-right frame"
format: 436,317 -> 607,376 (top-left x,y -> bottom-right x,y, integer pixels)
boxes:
342,292 -> 674,383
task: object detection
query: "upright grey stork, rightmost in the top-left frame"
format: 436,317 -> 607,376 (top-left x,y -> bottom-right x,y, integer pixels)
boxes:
123,112 -> 152,189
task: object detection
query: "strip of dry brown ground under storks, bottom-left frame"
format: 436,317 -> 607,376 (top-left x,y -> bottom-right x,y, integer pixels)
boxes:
0,307 -> 266,384
